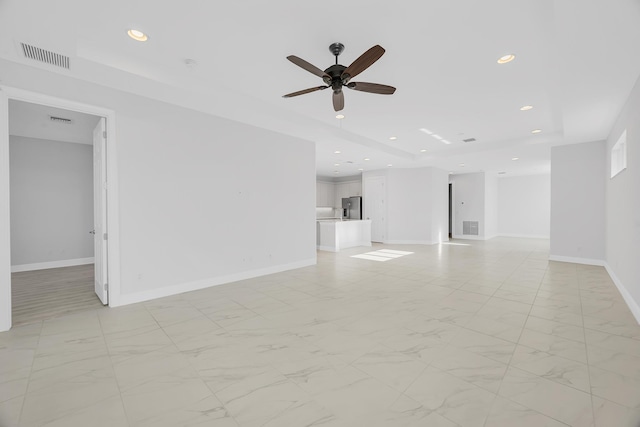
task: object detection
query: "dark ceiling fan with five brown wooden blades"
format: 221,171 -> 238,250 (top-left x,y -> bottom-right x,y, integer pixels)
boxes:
283,43 -> 396,111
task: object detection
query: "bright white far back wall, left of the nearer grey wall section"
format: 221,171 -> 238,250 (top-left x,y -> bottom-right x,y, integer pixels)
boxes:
498,174 -> 551,238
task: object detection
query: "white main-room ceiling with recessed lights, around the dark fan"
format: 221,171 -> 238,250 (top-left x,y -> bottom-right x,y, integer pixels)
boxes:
0,0 -> 640,177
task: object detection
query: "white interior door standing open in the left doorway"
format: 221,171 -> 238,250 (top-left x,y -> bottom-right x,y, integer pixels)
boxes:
93,117 -> 109,305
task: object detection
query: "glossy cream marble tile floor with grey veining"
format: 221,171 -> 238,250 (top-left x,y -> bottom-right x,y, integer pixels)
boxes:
0,238 -> 640,427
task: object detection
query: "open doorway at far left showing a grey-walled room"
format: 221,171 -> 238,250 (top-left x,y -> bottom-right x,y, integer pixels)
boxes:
9,100 -> 107,325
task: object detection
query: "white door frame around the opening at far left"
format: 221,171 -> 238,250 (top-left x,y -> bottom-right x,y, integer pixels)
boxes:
0,85 -> 120,332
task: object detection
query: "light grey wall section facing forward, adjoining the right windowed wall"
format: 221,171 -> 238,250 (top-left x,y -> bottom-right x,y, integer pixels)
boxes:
550,141 -> 606,264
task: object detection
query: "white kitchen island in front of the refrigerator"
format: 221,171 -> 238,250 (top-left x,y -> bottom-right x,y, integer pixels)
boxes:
316,219 -> 371,252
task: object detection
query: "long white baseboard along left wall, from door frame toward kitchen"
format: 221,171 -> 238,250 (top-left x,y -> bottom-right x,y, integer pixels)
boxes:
118,257 -> 317,306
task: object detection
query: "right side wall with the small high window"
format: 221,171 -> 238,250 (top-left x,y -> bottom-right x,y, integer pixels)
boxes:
605,74 -> 640,322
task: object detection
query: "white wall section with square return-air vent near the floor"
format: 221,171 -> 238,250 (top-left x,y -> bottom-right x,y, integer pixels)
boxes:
450,172 -> 485,239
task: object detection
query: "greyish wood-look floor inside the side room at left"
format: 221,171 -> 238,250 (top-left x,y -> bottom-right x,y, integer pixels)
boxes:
11,264 -> 103,326
